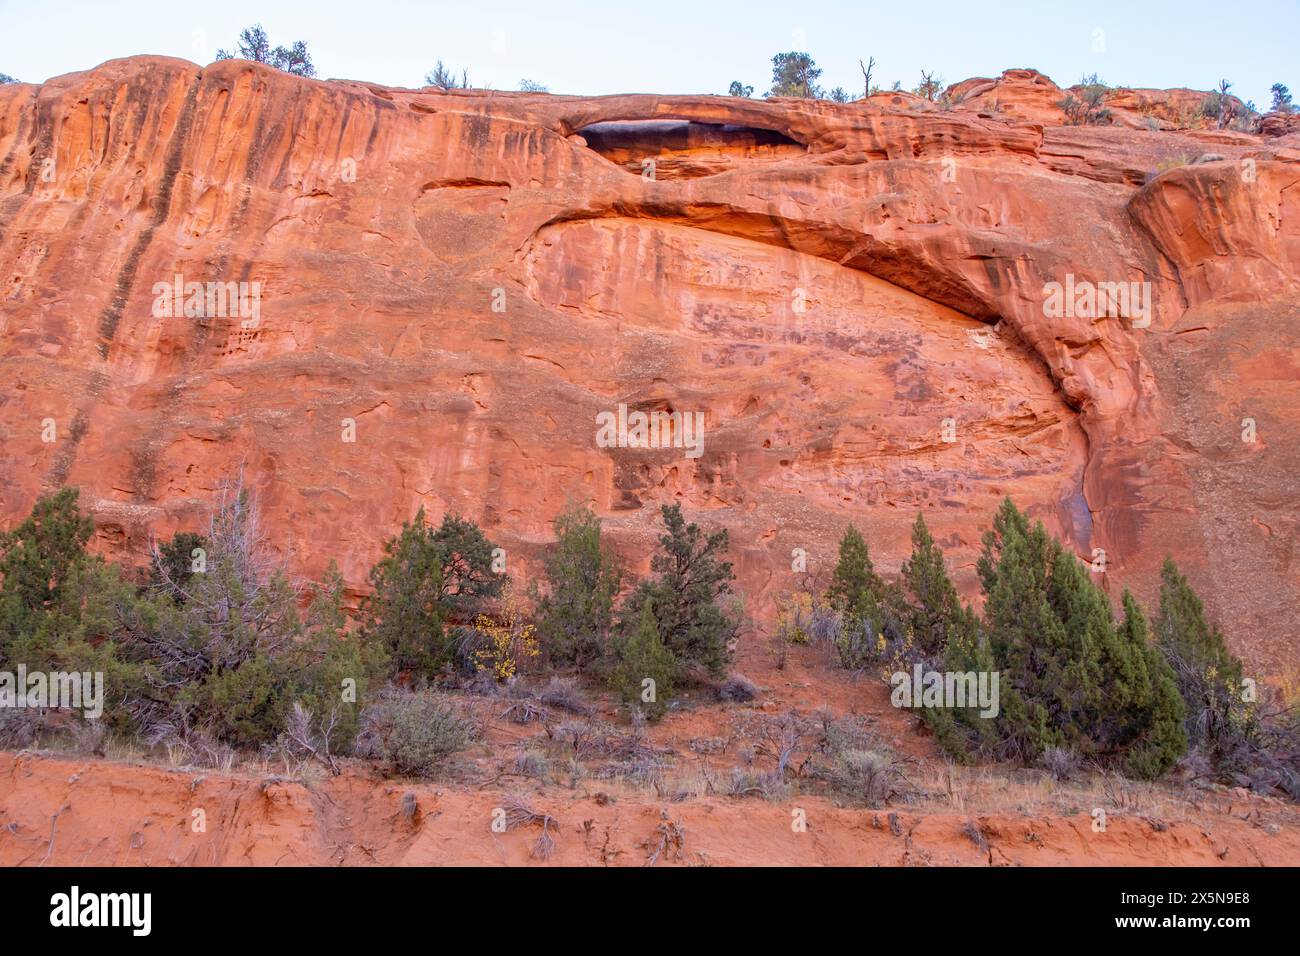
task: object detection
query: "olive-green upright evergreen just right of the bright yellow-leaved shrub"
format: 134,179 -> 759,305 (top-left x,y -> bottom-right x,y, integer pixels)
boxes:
537,505 -> 623,670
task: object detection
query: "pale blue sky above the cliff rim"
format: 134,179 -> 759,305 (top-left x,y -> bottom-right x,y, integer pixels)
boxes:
0,0 -> 1300,108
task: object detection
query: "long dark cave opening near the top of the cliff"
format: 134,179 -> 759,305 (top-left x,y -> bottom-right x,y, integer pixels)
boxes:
579,120 -> 807,179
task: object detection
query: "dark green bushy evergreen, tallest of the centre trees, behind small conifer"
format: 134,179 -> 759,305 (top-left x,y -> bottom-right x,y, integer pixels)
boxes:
620,505 -> 740,676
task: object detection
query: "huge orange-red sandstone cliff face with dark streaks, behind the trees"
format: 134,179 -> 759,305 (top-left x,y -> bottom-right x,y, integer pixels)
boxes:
0,57 -> 1300,671
